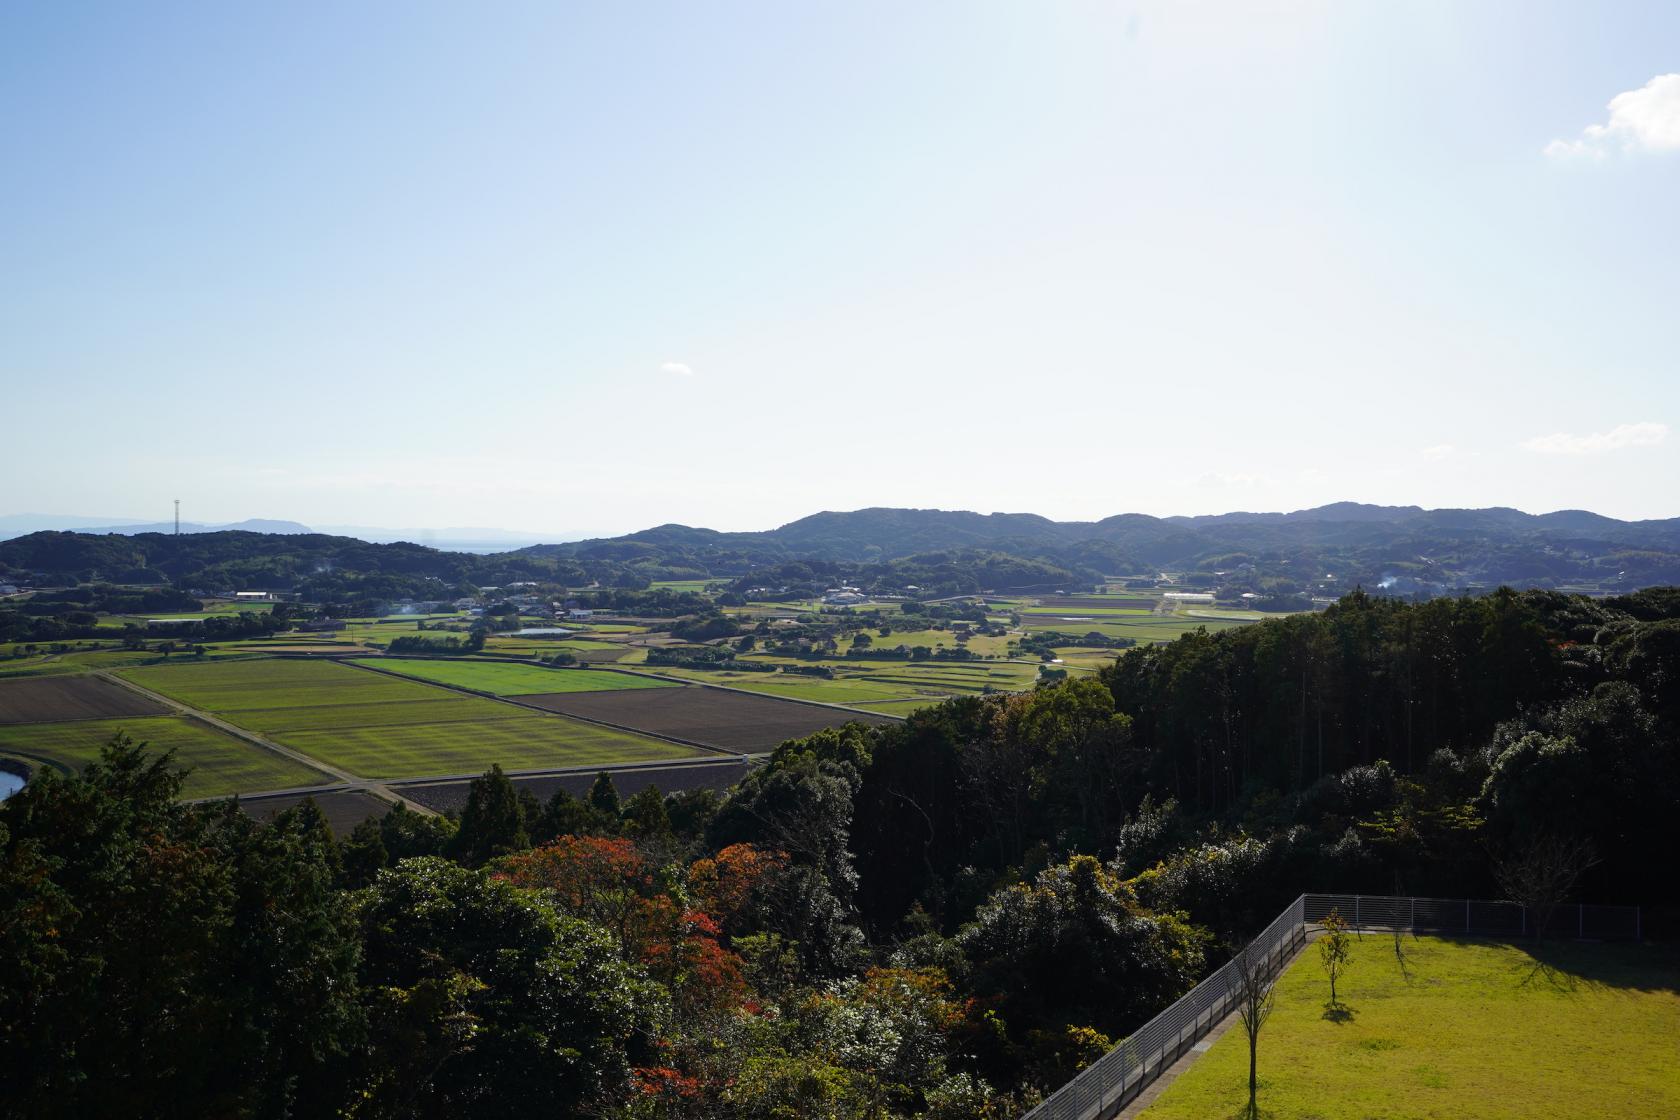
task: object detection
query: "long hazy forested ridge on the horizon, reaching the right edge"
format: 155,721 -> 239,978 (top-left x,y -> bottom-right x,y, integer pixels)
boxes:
522,502 -> 1680,594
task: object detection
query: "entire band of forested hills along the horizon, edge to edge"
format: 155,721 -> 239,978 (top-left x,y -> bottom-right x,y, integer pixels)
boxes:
0,502 -> 1680,598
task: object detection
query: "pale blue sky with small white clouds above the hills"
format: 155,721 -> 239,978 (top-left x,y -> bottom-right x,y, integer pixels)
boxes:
0,0 -> 1680,532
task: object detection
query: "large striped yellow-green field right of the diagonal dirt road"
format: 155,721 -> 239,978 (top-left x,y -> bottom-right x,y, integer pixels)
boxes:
123,658 -> 696,777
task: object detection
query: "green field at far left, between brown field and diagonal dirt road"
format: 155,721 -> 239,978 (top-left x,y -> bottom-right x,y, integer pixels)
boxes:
0,715 -> 324,798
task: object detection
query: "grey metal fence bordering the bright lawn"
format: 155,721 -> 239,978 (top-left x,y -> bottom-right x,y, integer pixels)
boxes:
1023,895 -> 1641,1120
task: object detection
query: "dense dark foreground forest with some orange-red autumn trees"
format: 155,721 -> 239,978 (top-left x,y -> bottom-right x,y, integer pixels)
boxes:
0,588 -> 1680,1120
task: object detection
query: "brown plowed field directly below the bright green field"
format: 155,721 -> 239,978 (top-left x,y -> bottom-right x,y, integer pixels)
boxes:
519,687 -> 894,752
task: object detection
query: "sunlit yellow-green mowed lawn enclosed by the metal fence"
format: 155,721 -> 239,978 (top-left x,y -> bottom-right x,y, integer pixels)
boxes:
1142,934 -> 1680,1120
